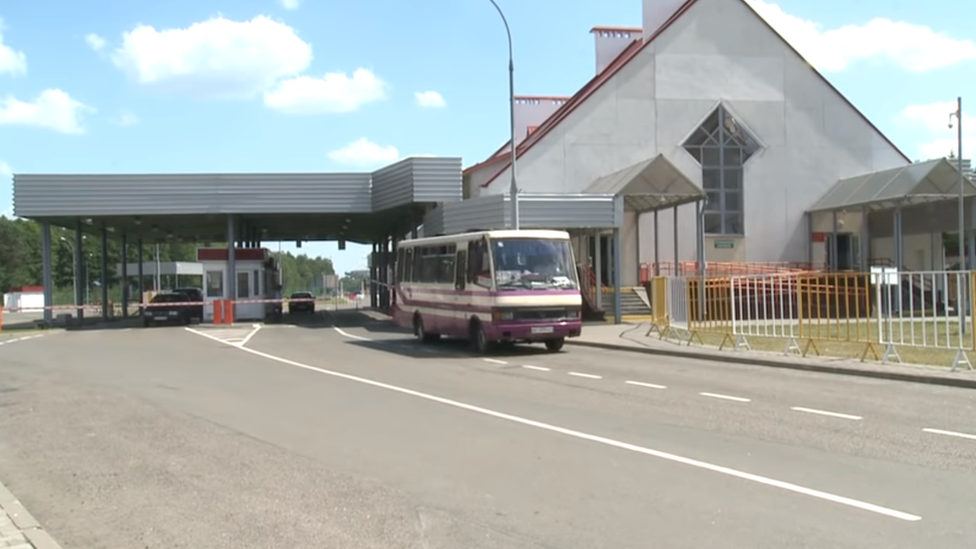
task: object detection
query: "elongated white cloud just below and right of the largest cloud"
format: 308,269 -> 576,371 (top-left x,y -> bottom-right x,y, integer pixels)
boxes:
264,69 -> 387,114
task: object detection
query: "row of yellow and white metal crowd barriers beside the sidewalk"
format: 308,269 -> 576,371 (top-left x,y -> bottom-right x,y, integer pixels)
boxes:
648,271 -> 976,367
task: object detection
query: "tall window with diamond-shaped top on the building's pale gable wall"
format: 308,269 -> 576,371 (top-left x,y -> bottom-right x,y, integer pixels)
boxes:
684,106 -> 760,235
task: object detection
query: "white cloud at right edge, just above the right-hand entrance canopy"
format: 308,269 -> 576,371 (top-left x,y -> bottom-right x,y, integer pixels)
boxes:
899,101 -> 976,160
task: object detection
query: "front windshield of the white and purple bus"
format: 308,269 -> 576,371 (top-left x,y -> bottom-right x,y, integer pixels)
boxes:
491,238 -> 579,291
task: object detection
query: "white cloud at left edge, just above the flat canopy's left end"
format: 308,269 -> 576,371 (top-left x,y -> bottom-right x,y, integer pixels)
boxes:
0,89 -> 95,134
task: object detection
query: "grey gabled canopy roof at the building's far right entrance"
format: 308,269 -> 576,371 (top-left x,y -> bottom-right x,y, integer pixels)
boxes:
809,158 -> 976,213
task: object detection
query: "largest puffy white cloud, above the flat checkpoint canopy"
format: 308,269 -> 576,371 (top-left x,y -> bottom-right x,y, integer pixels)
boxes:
112,16 -> 312,98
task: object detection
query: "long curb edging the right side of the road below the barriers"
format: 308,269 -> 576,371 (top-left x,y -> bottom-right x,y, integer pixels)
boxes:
566,340 -> 976,389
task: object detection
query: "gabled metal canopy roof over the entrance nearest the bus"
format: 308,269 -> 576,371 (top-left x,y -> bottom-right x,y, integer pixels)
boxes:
585,154 -> 705,212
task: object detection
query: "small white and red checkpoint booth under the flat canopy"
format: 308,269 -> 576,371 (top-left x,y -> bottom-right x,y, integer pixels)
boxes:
197,248 -> 279,322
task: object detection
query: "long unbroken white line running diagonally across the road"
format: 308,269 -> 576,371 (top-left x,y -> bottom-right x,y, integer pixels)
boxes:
191,330 -> 922,521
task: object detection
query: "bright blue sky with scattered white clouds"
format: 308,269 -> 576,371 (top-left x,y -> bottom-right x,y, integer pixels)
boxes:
0,0 -> 976,273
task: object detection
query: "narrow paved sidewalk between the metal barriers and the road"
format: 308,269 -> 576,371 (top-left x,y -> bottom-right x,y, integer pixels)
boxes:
566,322 -> 976,389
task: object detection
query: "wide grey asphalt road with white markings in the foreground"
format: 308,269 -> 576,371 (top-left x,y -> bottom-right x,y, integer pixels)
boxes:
0,310 -> 976,549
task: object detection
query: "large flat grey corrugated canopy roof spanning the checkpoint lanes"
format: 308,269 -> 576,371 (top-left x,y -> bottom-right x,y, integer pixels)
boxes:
14,157 -> 462,243
